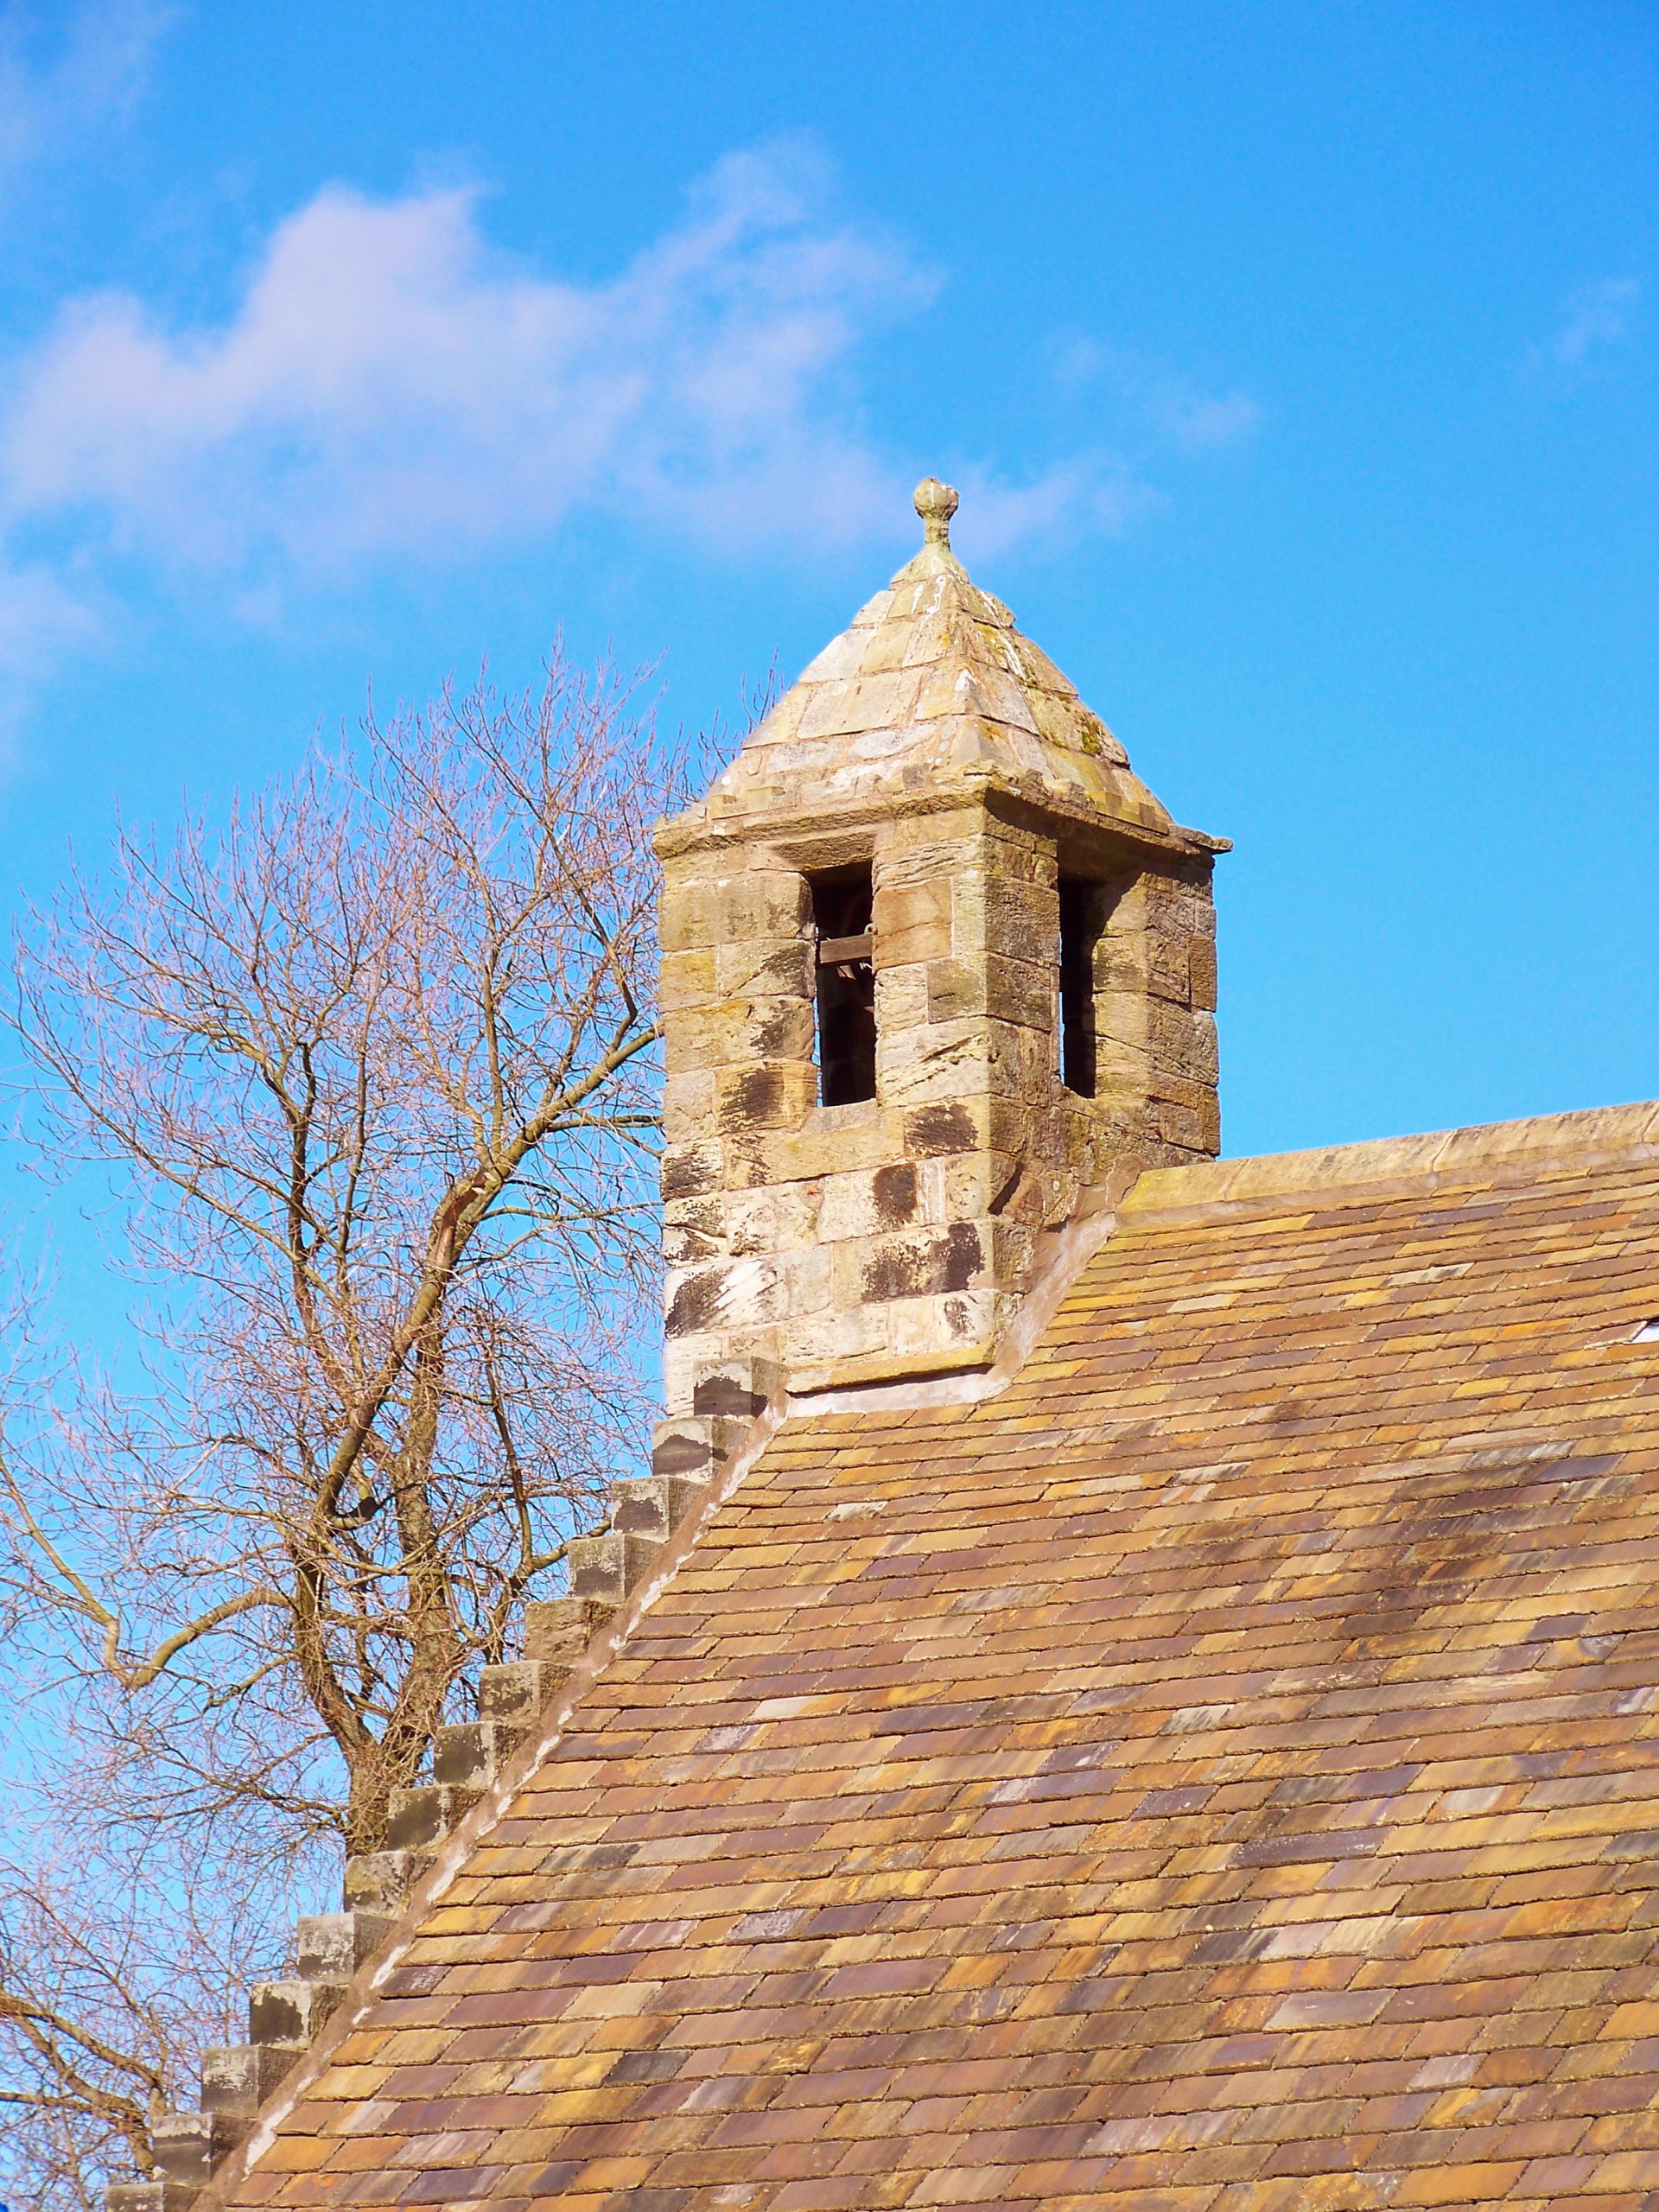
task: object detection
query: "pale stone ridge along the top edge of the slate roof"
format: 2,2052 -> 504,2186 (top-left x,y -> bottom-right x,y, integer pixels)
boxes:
1119,1099 -> 1659,1219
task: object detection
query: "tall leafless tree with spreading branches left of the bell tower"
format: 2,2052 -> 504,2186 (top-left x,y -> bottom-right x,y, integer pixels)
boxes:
0,664 -> 681,2203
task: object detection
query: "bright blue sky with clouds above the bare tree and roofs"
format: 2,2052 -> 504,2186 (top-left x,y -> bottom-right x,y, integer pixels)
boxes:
0,0 -> 1659,1153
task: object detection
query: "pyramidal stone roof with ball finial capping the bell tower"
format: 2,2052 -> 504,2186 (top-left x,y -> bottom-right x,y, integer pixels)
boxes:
692,475 -> 1225,852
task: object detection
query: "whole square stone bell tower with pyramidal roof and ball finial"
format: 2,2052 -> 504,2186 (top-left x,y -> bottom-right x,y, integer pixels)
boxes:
657,478 -> 1225,1415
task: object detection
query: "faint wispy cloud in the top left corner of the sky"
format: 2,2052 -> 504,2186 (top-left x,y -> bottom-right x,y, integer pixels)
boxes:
0,0 -> 177,208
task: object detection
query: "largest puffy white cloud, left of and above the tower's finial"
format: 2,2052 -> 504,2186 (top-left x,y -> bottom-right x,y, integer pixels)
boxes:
0,153 -> 929,573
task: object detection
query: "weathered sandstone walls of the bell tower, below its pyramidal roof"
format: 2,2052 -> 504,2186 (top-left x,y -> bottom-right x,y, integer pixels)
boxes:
661,794 -> 1219,1414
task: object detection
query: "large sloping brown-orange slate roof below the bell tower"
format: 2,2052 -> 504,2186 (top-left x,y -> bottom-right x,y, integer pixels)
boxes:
208,1109 -> 1659,2212
